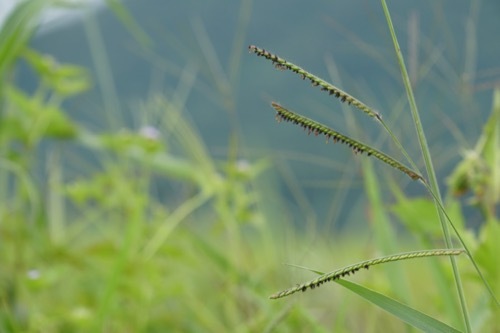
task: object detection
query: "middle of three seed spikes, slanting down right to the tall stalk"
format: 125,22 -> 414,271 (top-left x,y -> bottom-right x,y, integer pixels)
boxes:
271,102 -> 423,180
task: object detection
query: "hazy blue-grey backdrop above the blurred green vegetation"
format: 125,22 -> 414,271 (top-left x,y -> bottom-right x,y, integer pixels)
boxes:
13,0 -> 500,225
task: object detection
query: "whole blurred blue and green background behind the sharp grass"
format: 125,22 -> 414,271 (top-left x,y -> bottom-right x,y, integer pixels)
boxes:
0,0 -> 500,332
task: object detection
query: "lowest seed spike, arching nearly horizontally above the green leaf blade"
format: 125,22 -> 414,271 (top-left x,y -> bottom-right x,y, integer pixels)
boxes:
269,249 -> 465,299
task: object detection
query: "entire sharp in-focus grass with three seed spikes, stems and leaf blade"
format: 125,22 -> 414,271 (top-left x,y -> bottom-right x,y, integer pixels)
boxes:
249,29 -> 498,332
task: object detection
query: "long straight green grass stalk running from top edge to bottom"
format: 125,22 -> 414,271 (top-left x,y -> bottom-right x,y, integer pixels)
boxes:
381,0 -> 472,332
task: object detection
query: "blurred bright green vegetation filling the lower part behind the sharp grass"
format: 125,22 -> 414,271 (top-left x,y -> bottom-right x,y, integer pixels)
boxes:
0,2 -> 500,332
